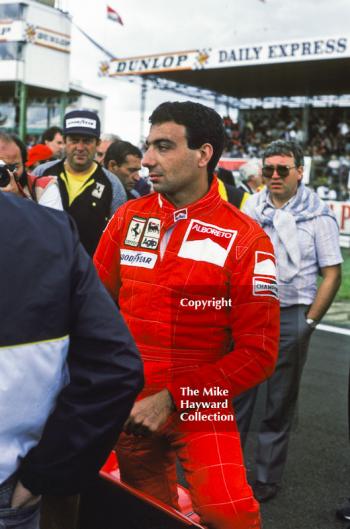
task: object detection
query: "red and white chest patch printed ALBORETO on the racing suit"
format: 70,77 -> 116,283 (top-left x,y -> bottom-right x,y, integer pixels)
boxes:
178,219 -> 237,266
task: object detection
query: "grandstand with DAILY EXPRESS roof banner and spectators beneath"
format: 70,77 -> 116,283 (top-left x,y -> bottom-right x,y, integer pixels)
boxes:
101,34 -> 350,246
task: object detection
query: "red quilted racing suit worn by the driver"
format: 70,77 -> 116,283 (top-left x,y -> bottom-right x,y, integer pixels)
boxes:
95,179 -> 279,529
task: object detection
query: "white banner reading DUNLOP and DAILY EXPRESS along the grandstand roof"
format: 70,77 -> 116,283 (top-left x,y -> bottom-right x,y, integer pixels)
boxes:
100,36 -> 350,77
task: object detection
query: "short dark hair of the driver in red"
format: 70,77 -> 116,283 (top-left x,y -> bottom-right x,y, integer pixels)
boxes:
149,101 -> 225,180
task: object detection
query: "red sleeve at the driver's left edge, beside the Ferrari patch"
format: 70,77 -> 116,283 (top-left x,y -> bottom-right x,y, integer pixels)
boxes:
94,206 -> 125,301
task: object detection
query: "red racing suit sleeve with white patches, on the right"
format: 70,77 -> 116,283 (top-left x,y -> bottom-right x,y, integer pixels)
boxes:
168,235 -> 280,409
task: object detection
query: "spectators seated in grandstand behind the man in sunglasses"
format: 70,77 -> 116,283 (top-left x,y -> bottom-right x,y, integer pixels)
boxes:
223,107 -> 350,200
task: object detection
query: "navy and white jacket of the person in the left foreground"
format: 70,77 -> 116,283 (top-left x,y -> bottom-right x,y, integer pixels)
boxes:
0,192 -> 143,494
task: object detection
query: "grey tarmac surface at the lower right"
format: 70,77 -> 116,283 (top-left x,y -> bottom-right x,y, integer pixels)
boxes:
246,322 -> 350,529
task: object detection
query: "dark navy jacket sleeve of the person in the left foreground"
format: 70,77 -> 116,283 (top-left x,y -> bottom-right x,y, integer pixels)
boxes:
19,222 -> 142,495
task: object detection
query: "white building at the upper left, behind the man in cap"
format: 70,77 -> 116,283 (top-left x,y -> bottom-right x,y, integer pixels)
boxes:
0,0 -> 104,138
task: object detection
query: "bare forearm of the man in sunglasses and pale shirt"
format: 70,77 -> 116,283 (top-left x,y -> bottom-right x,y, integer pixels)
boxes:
306,264 -> 341,321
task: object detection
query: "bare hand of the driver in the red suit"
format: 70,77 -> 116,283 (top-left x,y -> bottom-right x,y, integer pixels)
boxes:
124,389 -> 175,437
